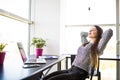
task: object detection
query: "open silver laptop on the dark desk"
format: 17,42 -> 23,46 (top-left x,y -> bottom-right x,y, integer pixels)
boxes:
17,42 -> 46,64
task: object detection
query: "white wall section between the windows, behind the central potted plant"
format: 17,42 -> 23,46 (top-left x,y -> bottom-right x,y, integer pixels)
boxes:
32,0 -> 60,55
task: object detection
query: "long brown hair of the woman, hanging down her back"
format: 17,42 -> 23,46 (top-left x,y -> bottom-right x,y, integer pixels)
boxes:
90,25 -> 103,68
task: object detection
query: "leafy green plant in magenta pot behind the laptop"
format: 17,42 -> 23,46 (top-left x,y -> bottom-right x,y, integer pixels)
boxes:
32,37 -> 46,58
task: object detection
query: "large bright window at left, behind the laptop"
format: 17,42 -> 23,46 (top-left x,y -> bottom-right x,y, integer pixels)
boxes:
0,0 -> 29,59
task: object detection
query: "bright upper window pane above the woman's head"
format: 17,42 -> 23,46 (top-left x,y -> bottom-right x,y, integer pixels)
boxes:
65,0 -> 116,25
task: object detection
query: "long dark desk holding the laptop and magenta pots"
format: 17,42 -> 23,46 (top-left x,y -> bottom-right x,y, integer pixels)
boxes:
0,57 -> 66,80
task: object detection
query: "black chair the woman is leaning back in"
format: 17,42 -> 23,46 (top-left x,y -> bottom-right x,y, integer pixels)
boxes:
71,55 -> 101,80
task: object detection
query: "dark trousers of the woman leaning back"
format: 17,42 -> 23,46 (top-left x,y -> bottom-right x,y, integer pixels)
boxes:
43,66 -> 88,80
